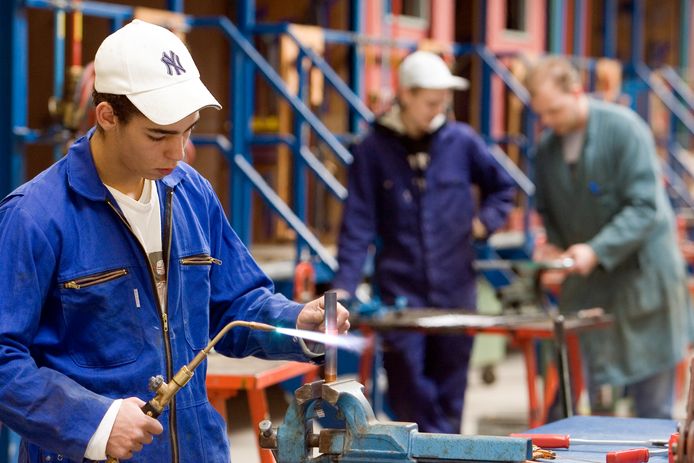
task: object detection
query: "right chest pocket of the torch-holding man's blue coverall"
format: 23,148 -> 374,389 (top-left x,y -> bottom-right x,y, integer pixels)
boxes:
179,254 -> 222,350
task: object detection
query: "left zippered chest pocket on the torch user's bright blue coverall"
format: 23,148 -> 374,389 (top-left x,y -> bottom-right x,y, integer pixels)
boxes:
60,268 -> 144,368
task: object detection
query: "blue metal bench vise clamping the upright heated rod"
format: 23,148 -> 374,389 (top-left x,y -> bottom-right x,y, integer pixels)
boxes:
260,380 -> 533,463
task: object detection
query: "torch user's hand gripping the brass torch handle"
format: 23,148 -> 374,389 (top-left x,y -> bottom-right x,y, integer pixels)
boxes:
106,397 -> 164,460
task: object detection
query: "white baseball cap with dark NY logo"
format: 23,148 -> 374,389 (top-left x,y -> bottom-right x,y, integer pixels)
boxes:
94,19 -> 222,125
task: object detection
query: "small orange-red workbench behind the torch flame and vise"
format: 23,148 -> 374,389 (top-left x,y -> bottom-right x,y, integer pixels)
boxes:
206,353 -> 318,463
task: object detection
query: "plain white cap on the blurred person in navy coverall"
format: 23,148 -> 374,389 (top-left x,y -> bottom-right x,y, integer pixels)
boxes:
398,51 -> 470,90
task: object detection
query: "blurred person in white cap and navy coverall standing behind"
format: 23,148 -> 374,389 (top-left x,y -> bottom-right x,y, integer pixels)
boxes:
333,51 -> 514,433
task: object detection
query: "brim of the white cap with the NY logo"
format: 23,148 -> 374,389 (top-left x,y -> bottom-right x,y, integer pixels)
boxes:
127,78 -> 222,125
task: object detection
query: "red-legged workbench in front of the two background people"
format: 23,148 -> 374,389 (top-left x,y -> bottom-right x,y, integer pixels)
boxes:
353,309 -> 613,428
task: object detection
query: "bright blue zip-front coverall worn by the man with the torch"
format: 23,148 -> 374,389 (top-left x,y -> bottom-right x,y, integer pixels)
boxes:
0,133 -> 307,463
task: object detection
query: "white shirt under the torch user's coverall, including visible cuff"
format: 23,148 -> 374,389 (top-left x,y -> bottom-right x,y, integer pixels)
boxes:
84,180 -> 166,460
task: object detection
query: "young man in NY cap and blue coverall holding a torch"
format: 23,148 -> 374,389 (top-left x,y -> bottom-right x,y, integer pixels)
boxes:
0,20 -> 349,463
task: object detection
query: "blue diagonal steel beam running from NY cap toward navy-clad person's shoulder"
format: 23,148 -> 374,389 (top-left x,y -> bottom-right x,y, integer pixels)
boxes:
190,17 -> 353,164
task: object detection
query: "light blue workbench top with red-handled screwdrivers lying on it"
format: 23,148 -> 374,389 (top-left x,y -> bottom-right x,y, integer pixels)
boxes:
527,416 -> 677,463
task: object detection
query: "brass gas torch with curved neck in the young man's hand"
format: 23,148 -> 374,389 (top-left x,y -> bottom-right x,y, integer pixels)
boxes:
106,320 -> 277,463
